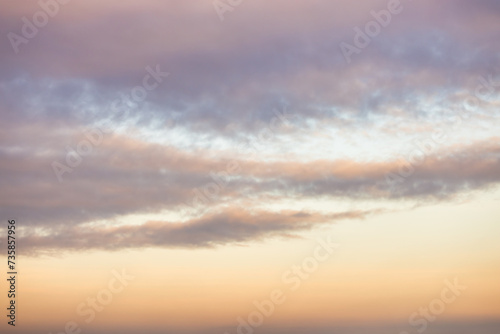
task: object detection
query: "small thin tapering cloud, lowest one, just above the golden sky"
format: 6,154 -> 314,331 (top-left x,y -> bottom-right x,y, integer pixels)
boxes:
18,208 -> 373,254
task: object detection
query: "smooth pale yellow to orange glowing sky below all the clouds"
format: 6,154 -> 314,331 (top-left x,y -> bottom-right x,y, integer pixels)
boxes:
1,189 -> 500,330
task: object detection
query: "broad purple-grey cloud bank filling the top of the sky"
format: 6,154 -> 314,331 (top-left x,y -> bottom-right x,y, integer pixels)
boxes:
0,0 -> 499,135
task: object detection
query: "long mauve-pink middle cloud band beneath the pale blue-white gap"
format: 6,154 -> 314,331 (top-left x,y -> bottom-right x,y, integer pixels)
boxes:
0,107 -> 500,232
